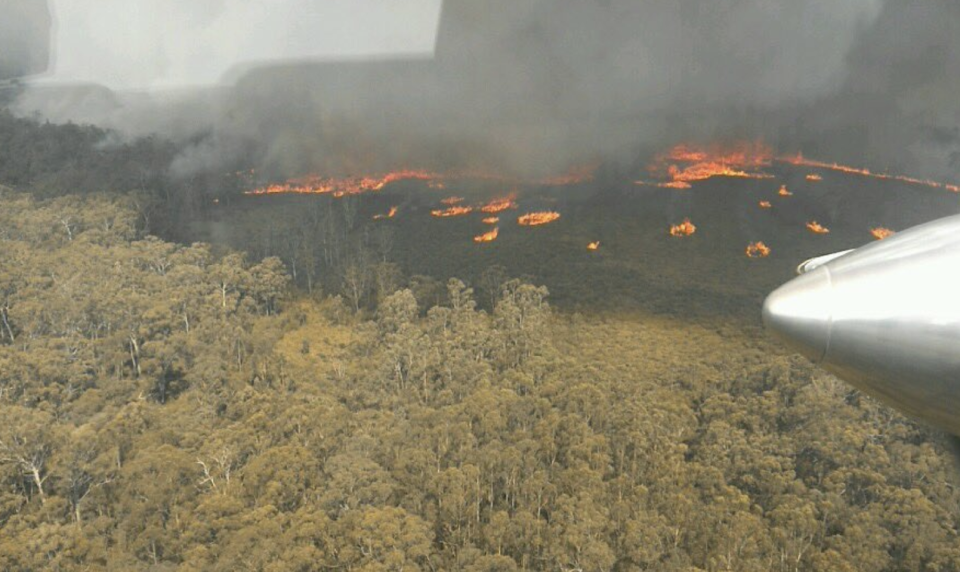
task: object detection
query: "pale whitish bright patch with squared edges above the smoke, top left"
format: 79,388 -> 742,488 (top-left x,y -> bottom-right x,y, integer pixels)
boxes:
48,0 -> 441,89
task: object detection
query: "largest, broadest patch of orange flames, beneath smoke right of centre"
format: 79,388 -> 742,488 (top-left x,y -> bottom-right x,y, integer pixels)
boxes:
637,142 -> 773,189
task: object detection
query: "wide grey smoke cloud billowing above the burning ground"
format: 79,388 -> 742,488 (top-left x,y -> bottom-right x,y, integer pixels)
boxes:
11,0 -> 960,183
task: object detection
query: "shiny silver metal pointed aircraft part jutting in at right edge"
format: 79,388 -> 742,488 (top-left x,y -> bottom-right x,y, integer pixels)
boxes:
764,216 -> 960,434
